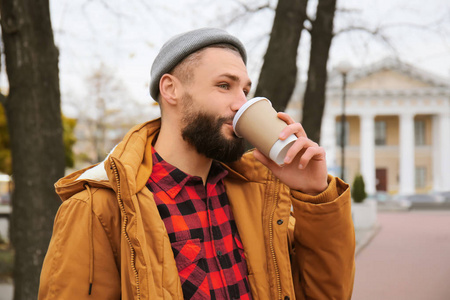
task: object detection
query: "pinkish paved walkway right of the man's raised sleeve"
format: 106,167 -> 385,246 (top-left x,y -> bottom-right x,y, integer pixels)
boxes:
352,210 -> 450,300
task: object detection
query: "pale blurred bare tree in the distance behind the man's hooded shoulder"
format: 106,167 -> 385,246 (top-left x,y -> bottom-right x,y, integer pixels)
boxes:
71,64 -> 152,164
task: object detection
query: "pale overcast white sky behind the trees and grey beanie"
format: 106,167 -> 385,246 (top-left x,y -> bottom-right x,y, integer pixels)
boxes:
50,0 -> 450,119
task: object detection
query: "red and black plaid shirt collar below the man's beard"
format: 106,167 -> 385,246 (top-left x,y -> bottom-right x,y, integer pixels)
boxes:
151,147 -> 228,199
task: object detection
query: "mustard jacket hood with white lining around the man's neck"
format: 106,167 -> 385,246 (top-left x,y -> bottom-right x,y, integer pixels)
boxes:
55,119 -> 268,201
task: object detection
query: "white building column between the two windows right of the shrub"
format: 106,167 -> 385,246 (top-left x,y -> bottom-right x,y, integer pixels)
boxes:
399,113 -> 415,195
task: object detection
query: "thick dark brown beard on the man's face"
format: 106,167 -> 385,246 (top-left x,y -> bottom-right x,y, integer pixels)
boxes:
181,94 -> 245,163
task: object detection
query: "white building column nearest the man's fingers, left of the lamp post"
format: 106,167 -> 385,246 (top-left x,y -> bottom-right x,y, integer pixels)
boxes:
320,114 -> 339,176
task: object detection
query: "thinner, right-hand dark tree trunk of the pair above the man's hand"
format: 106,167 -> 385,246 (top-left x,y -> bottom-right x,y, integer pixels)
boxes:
302,0 -> 336,142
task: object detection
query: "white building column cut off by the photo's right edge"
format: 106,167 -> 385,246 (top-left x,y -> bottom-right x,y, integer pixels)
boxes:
433,113 -> 450,192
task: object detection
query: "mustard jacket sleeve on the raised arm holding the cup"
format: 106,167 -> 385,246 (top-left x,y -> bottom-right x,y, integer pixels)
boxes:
291,176 -> 355,300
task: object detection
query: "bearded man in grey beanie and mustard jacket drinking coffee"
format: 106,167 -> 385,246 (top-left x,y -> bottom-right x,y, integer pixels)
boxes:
39,28 -> 355,300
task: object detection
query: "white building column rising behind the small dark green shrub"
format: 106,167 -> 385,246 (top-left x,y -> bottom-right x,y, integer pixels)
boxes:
359,114 -> 376,195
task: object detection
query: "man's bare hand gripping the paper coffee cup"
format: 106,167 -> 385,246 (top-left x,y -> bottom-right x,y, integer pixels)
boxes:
253,113 -> 328,195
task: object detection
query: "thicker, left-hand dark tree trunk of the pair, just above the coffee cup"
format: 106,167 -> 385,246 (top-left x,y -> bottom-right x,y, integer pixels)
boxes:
255,0 -> 308,111
